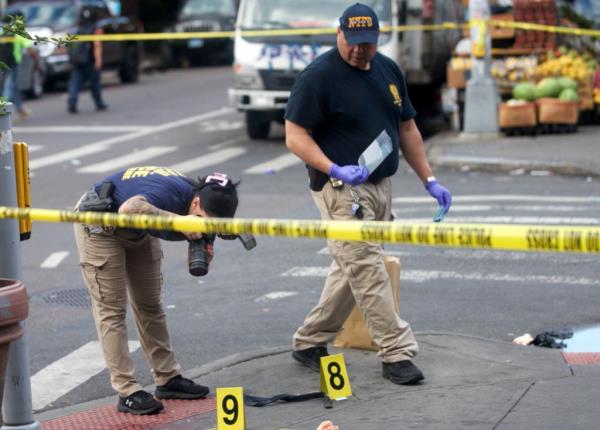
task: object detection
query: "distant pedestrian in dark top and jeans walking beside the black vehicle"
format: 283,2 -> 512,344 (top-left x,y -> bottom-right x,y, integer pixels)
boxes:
67,6 -> 108,113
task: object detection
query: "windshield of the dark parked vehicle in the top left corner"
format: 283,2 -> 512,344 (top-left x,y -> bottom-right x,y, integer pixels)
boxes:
6,1 -> 75,28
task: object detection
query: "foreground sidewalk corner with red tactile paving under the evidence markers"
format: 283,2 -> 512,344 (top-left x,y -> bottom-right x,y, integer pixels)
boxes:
36,333 -> 600,430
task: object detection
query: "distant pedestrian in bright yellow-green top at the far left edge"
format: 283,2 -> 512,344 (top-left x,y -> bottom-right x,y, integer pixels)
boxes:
0,11 -> 42,120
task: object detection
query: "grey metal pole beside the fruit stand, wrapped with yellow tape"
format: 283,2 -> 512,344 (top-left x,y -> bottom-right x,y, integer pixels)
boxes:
464,0 -> 500,134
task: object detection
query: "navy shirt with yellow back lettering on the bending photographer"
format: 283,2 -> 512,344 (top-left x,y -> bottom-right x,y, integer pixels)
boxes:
94,166 -> 194,240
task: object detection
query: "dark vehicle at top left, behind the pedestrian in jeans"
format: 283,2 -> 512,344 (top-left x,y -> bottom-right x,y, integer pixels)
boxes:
7,0 -> 142,87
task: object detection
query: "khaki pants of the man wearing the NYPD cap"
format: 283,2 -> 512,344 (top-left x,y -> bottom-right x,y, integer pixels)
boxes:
293,178 -> 418,363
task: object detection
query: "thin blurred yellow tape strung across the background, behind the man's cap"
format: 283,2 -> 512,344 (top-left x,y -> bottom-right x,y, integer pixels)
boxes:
0,19 -> 600,42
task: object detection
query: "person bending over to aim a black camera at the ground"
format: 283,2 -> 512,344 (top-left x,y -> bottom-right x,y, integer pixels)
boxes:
74,166 -> 238,415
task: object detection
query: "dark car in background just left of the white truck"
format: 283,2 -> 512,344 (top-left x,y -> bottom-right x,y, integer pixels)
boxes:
161,0 -> 238,67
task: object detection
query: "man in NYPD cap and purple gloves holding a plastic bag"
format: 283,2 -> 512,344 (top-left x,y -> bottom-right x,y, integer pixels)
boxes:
285,3 -> 451,384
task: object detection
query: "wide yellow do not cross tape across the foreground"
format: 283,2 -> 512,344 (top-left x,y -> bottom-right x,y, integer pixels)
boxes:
0,206 -> 600,253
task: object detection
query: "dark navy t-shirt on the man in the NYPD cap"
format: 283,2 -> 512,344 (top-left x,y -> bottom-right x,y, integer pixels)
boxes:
285,48 -> 416,189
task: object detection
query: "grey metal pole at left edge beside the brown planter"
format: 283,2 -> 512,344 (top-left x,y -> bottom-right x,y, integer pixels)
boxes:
0,103 -> 41,430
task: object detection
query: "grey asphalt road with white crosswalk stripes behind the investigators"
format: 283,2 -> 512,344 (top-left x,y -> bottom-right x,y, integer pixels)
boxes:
5,68 -> 600,410
